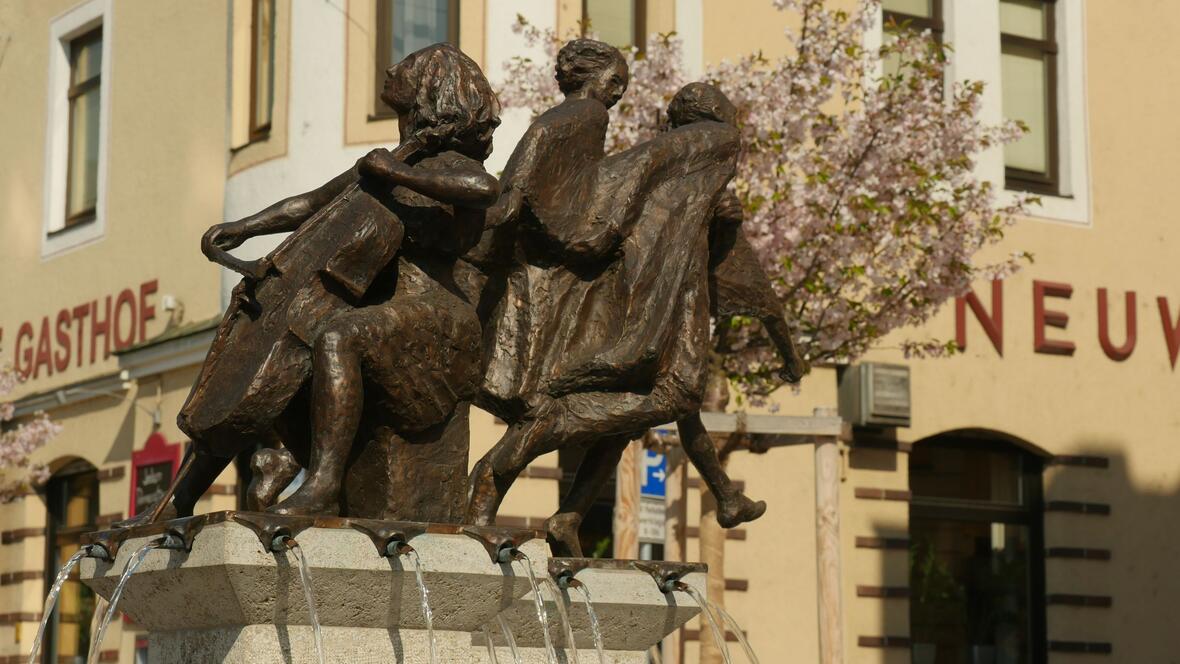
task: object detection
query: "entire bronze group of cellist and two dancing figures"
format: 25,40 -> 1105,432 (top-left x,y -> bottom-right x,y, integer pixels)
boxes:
129,39 -> 807,554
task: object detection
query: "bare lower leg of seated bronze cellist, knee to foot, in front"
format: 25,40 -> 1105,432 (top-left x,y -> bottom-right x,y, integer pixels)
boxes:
269,325 -> 365,514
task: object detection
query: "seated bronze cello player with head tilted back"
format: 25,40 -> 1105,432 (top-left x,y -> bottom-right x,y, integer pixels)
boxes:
123,44 -> 499,528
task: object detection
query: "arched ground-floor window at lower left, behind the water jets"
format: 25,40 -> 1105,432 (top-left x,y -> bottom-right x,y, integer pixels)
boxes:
41,460 -> 98,664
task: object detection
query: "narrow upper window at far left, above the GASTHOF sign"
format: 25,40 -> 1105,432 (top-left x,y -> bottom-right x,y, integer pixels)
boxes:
63,27 -> 103,231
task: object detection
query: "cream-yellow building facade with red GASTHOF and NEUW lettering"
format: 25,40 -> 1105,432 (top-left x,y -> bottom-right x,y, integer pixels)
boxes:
0,0 -> 1180,664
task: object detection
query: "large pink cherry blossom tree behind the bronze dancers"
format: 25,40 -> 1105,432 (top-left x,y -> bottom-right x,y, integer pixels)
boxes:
499,0 -> 1035,396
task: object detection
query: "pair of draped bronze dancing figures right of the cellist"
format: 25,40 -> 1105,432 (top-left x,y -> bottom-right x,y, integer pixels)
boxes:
457,46 -> 804,554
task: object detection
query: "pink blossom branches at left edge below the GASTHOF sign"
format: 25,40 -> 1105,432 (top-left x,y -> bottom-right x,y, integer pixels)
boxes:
0,367 -> 61,502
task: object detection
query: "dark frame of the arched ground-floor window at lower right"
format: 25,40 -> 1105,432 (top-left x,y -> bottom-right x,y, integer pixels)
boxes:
909,433 -> 1048,663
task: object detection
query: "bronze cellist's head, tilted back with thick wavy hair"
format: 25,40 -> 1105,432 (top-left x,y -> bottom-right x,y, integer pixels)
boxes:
381,44 -> 500,162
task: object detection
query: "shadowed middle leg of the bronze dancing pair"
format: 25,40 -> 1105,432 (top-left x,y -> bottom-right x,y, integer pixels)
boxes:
545,435 -> 634,558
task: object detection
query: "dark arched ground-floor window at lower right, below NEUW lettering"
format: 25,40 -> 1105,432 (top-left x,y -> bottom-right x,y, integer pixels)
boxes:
910,435 -> 1045,664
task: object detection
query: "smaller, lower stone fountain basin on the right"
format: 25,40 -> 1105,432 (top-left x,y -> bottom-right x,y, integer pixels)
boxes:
492,558 -> 707,652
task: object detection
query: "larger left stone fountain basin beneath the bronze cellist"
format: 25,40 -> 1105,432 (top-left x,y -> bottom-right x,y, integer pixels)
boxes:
81,513 -> 548,633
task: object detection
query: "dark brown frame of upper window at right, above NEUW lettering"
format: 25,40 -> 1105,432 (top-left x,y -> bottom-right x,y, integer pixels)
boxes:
997,0 -> 1061,196
